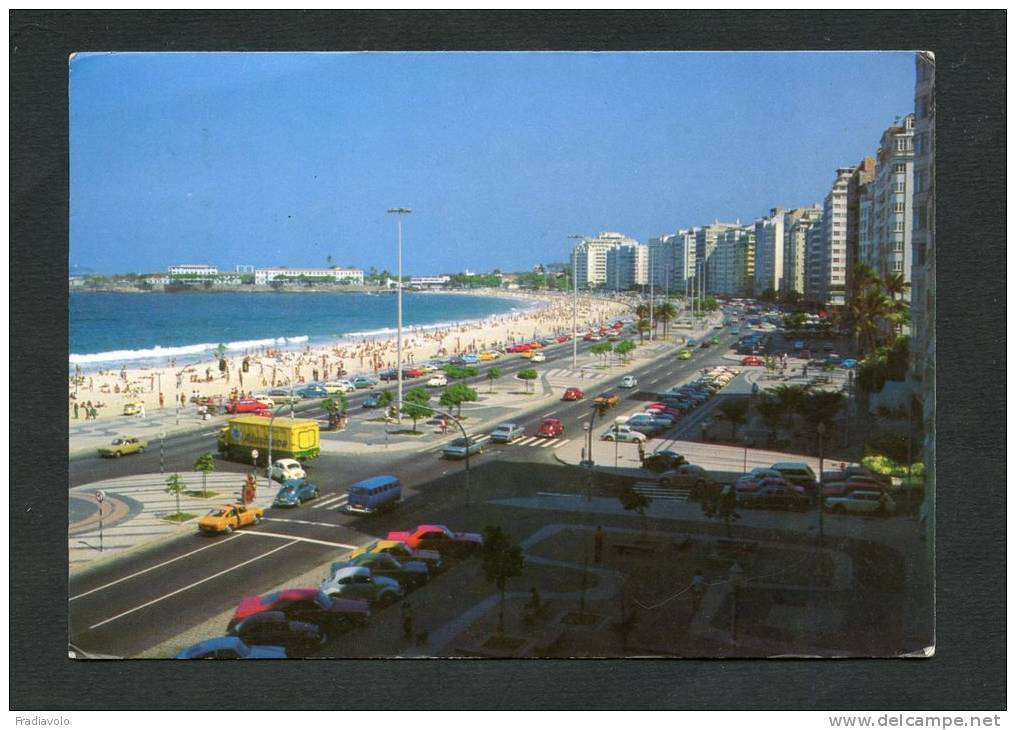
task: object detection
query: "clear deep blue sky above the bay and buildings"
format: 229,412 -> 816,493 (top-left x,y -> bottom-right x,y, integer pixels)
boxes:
70,52 -> 914,274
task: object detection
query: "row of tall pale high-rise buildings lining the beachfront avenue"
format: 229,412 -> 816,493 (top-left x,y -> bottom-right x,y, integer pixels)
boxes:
573,114 -> 931,306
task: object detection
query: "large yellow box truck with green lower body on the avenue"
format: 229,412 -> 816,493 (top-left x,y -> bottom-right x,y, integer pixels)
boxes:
218,415 -> 321,464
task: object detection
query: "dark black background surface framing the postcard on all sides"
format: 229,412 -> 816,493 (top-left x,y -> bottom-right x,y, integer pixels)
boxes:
9,10 -> 1006,710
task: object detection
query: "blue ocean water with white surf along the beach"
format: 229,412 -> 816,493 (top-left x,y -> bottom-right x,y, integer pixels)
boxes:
69,292 -> 531,368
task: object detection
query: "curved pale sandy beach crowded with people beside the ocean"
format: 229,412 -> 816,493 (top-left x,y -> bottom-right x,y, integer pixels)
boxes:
68,290 -> 632,422
